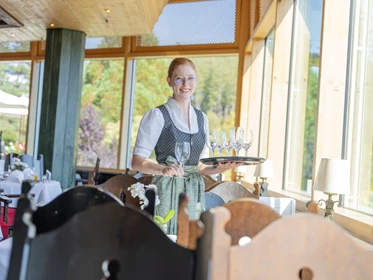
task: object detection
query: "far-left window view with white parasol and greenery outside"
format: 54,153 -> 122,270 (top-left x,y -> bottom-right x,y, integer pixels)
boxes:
0,61 -> 31,153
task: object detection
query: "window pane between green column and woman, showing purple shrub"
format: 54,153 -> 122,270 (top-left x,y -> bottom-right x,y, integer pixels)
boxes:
77,60 -> 124,168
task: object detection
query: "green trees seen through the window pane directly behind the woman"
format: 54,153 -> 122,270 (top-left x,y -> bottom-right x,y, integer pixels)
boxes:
131,56 -> 238,167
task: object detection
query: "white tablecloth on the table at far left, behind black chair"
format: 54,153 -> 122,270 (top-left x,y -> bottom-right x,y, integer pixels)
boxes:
0,181 -> 62,207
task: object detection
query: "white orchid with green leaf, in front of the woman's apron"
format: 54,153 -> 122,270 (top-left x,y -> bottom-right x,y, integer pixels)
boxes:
128,183 -> 175,232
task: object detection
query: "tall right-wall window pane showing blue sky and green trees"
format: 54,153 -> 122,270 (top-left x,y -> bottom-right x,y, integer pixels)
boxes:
284,0 -> 322,195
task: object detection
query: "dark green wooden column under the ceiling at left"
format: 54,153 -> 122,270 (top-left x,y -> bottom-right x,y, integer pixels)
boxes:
38,28 -> 85,188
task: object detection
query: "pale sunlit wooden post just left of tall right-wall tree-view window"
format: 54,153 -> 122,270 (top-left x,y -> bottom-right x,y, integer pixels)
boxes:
268,0 -> 293,189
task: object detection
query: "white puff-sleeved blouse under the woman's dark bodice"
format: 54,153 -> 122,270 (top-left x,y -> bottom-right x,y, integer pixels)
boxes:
133,97 -> 209,158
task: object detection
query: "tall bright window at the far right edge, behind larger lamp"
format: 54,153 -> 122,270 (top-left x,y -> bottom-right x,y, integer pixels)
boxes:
345,0 -> 373,214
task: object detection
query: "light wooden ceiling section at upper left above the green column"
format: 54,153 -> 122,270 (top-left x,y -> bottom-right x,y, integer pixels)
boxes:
0,0 -> 168,42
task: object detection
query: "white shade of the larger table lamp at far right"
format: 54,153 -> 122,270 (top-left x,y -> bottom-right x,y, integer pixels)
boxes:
314,158 -> 350,194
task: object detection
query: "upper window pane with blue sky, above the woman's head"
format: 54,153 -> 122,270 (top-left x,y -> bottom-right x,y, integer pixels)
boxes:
137,0 -> 236,47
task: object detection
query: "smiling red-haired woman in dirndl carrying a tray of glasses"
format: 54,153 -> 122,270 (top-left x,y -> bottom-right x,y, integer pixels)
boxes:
132,57 -> 240,234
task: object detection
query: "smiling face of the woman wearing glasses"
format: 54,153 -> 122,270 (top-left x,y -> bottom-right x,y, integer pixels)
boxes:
167,65 -> 196,101
